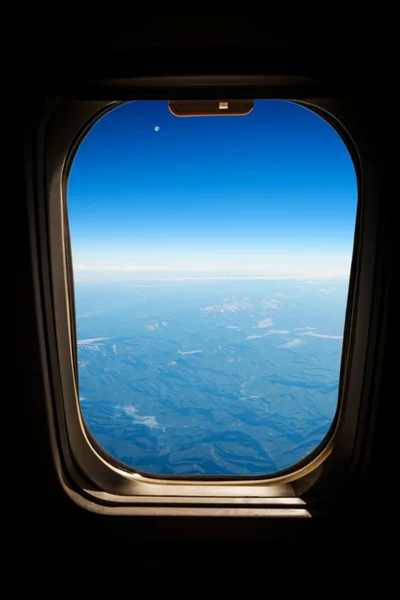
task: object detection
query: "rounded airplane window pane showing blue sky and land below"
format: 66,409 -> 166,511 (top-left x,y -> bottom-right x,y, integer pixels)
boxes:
68,100 -> 357,477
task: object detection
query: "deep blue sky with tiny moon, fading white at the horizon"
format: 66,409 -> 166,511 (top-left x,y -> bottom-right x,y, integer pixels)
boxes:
68,100 -> 357,280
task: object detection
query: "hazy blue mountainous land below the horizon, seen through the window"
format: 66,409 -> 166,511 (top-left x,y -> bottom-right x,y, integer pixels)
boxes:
76,280 -> 347,475
